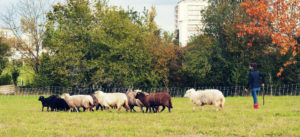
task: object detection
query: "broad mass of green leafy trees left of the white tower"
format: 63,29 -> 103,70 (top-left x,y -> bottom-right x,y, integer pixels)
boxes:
40,0 -> 176,87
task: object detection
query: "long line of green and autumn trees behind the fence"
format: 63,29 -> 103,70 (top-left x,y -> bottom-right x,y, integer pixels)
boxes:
1,0 -> 300,88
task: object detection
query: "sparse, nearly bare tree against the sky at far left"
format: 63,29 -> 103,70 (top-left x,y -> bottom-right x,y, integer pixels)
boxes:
1,0 -> 54,73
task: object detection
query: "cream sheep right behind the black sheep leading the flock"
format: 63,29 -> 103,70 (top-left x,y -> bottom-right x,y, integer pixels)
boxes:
62,93 -> 93,112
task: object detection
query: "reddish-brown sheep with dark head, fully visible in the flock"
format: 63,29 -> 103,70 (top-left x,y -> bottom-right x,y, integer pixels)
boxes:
135,92 -> 173,113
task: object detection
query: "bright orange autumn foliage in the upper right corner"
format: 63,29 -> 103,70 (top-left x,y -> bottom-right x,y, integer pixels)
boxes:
237,0 -> 300,76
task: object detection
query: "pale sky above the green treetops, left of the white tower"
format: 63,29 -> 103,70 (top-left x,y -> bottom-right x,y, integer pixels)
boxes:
0,0 -> 179,33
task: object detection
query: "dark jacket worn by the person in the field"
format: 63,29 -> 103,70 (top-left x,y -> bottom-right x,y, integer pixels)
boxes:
246,69 -> 265,88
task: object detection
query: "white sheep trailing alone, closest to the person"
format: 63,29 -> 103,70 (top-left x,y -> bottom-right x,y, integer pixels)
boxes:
184,89 -> 225,112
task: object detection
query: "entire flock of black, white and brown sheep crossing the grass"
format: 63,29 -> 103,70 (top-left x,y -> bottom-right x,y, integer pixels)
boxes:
39,89 -> 225,113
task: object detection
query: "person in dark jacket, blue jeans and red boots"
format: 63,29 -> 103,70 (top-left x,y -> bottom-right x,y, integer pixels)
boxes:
245,63 -> 265,109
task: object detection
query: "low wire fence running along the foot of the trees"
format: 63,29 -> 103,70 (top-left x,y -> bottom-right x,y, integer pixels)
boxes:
7,84 -> 300,97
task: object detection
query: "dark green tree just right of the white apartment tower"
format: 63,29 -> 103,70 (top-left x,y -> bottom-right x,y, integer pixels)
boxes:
199,0 -> 250,85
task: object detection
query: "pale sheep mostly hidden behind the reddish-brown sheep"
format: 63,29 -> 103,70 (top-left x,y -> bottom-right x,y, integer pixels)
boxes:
126,89 -> 149,112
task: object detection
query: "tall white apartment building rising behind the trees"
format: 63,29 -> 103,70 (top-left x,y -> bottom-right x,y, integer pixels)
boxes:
175,0 -> 208,47
